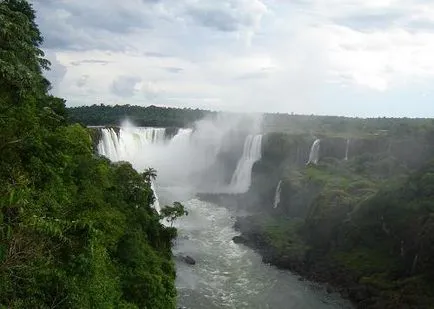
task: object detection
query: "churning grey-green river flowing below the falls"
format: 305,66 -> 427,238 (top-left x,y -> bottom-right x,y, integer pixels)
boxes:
170,199 -> 352,309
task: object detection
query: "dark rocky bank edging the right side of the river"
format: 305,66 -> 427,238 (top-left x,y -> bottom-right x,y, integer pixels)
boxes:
233,202 -> 434,309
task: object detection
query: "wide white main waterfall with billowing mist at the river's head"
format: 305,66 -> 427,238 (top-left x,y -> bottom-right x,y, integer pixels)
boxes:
98,115 -> 262,196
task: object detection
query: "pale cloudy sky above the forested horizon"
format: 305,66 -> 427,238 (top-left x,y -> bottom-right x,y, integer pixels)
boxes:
31,0 -> 434,117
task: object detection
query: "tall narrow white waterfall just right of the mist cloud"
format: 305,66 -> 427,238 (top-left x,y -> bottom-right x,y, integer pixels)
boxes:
230,135 -> 262,193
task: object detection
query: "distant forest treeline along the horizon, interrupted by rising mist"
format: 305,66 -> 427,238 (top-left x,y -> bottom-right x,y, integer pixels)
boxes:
67,104 -> 434,144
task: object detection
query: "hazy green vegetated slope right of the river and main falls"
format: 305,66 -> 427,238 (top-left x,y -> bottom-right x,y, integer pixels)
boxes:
241,131 -> 434,308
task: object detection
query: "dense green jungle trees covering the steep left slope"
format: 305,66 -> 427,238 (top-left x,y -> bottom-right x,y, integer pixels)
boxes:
0,0 -> 176,309
